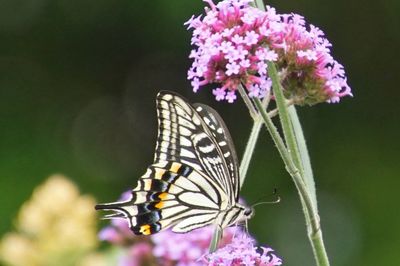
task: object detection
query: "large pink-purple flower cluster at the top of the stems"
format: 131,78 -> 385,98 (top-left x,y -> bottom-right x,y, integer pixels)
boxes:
185,0 -> 352,105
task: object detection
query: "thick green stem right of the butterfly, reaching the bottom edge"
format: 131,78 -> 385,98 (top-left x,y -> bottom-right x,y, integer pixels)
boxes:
254,62 -> 329,266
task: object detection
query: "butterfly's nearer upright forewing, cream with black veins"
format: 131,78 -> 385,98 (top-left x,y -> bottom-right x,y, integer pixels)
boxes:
155,92 -> 236,193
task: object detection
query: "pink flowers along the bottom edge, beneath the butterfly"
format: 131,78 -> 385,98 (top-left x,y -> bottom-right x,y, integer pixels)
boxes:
99,220 -> 282,266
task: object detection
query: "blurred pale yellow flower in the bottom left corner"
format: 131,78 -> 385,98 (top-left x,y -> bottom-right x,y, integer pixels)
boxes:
0,175 -> 107,266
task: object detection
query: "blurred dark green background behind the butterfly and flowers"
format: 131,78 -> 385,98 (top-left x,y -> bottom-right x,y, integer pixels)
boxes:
0,0 -> 400,266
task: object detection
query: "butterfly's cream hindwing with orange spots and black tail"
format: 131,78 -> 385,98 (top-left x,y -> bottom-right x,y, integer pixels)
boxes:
97,162 -> 226,235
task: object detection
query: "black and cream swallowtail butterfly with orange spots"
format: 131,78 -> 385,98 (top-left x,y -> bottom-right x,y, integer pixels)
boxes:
95,91 -> 253,235
